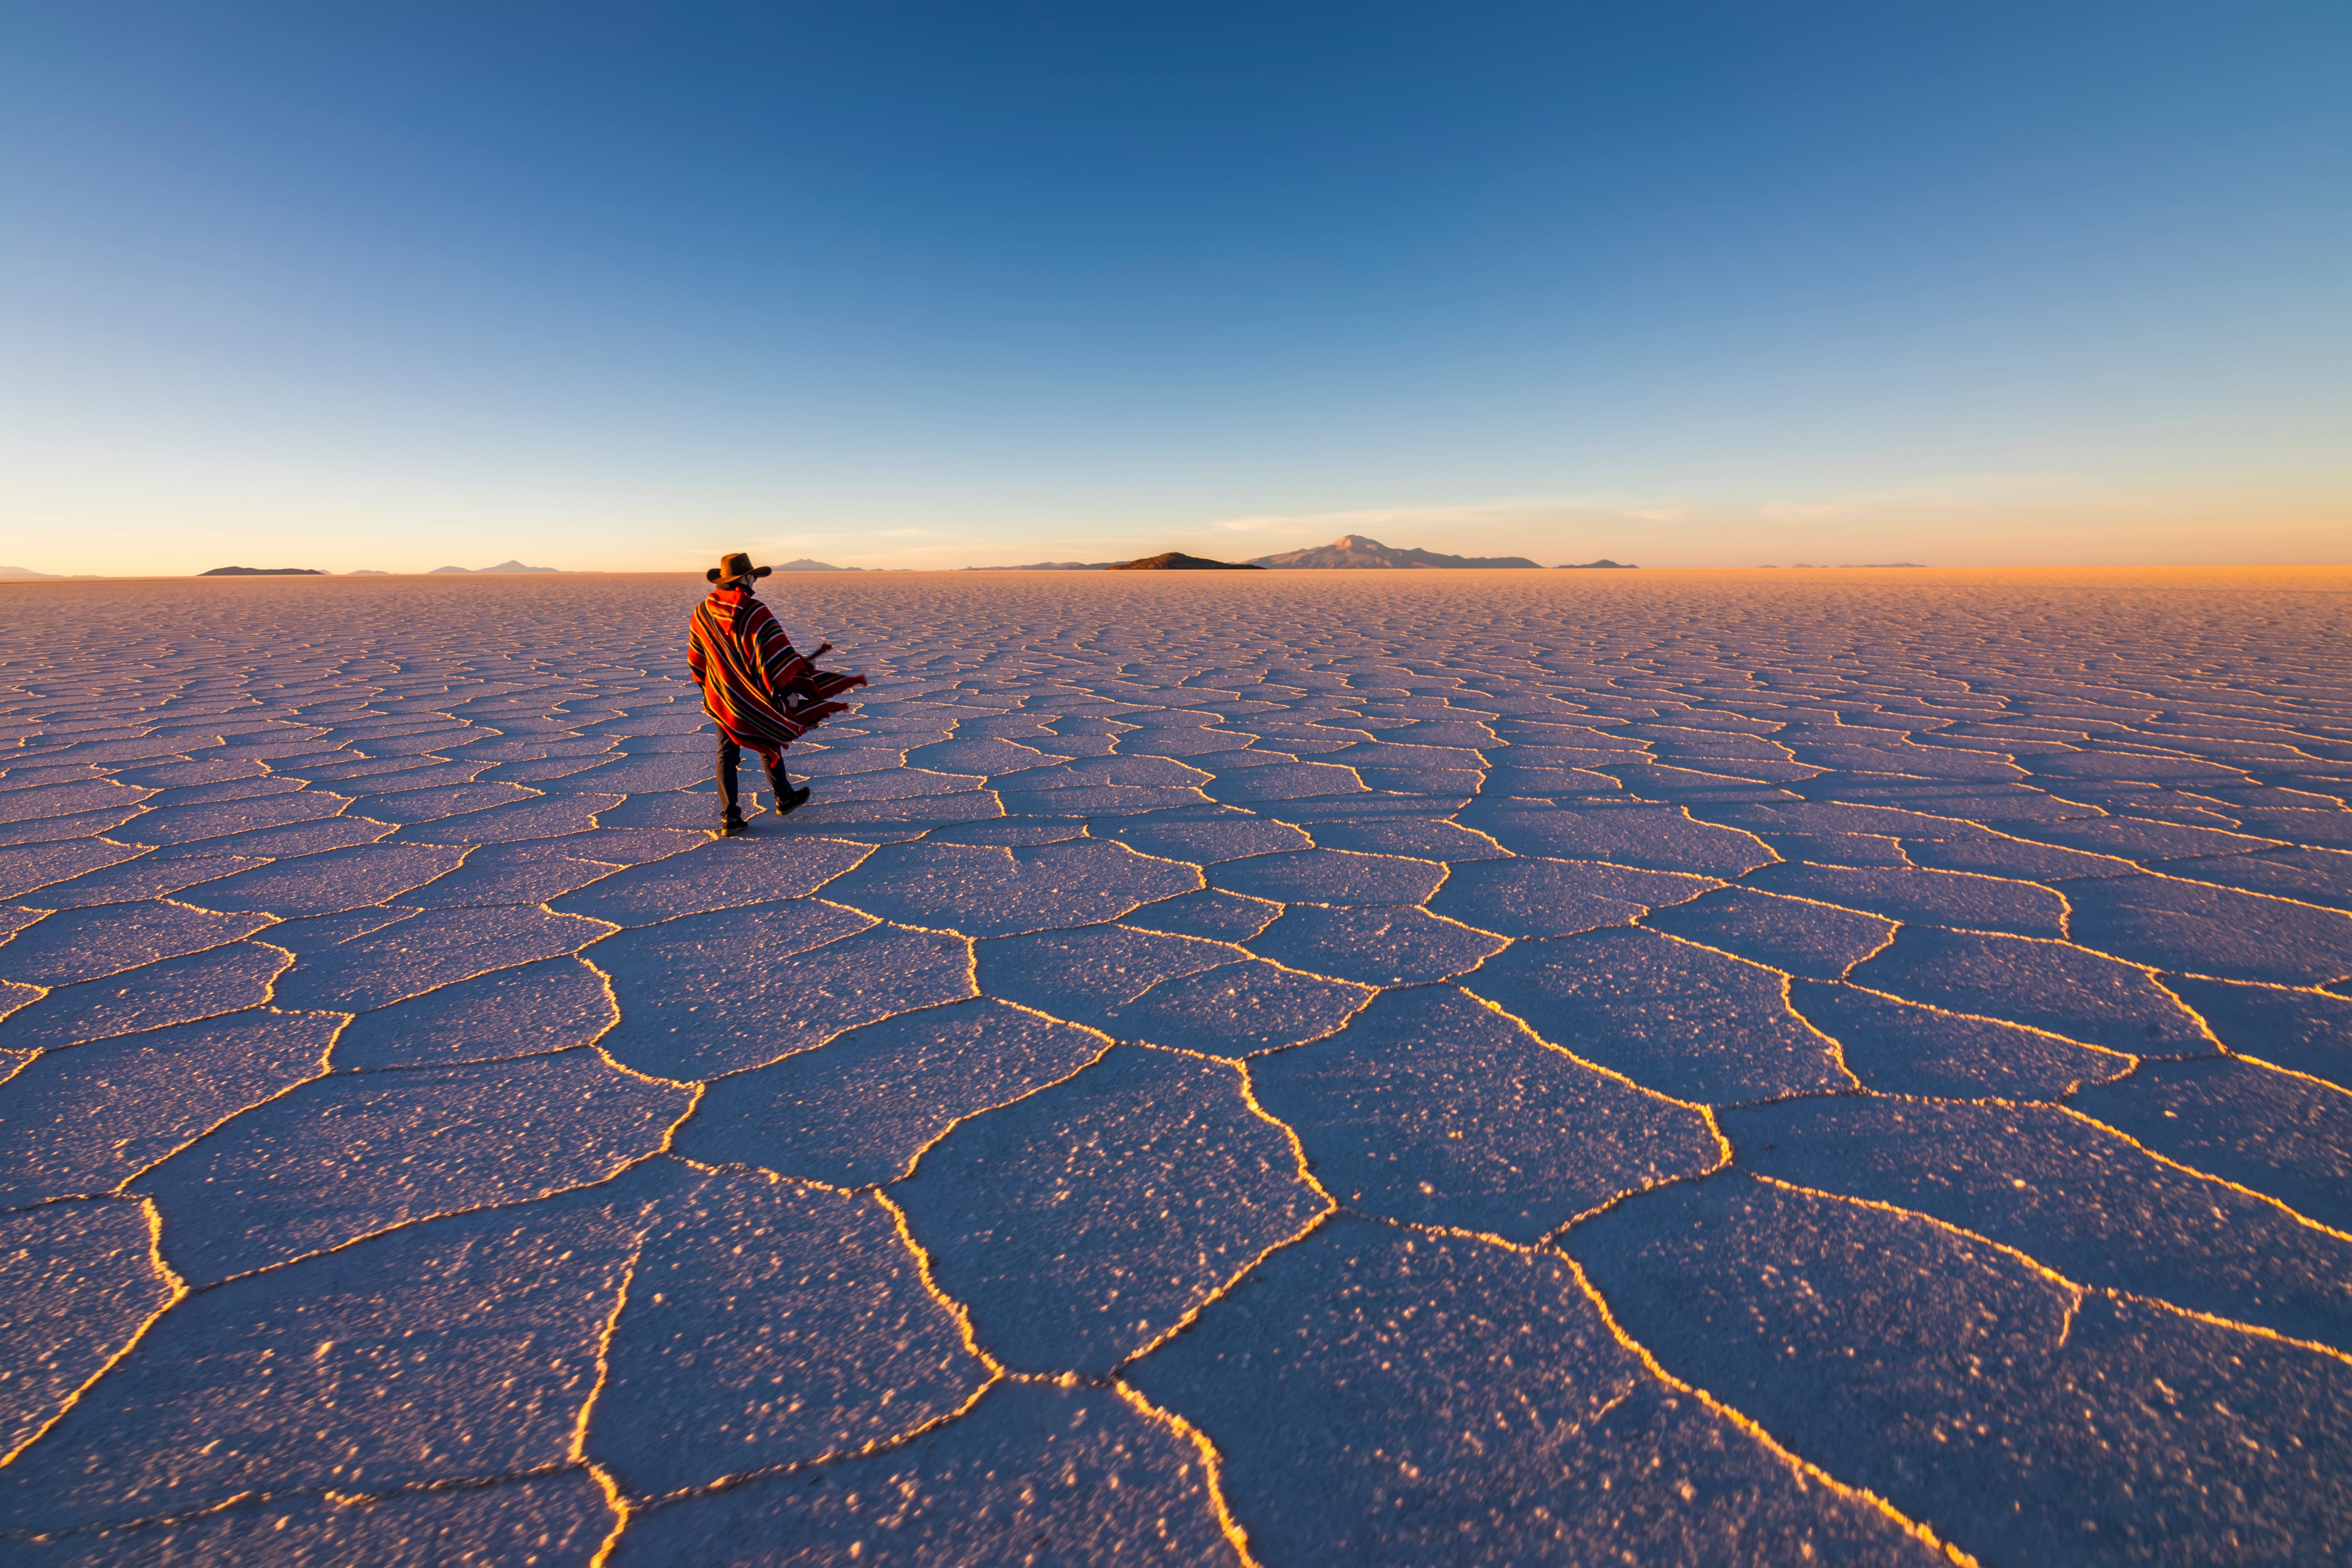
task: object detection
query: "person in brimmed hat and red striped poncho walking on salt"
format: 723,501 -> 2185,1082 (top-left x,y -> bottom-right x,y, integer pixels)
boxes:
687,552 -> 866,839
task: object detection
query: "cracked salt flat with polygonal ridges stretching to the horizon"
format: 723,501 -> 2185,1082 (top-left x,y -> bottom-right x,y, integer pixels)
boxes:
0,569 -> 2352,1566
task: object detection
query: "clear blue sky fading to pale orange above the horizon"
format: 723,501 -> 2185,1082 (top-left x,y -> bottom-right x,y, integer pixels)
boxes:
0,0 -> 2352,574
